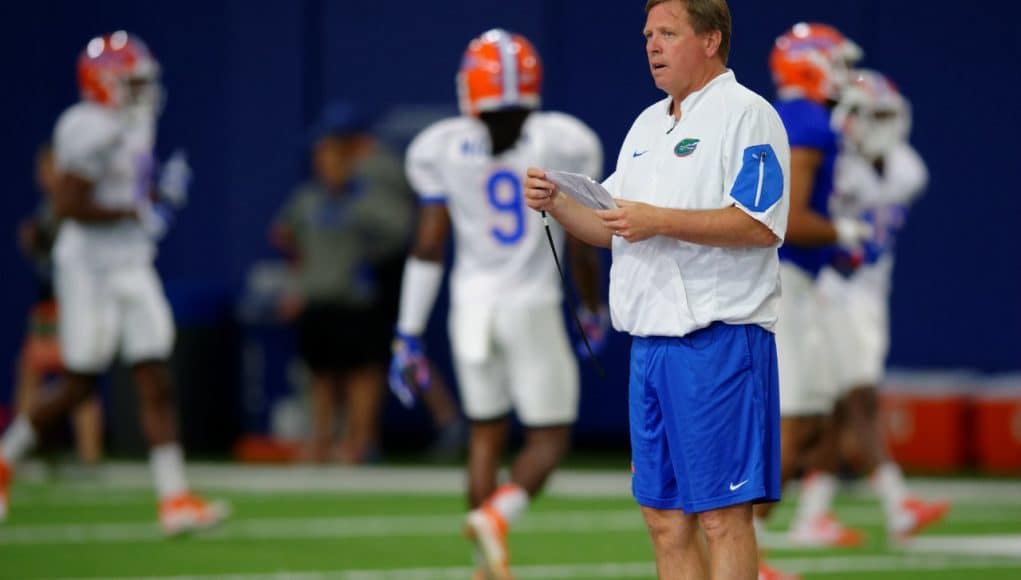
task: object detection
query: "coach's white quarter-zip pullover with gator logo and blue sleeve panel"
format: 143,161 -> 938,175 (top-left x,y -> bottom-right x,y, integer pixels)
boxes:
603,70 -> 790,336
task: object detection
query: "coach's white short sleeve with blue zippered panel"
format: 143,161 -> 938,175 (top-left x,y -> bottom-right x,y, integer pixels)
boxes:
723,101 -> 790,242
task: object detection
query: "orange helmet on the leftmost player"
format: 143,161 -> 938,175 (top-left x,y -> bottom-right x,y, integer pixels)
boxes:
78,31 -> 160,107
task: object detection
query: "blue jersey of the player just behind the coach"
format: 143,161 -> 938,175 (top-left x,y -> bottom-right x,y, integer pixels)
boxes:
774,99 -> 840,276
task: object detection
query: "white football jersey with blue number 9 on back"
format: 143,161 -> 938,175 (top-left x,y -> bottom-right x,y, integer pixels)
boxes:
406,112 -> 602,305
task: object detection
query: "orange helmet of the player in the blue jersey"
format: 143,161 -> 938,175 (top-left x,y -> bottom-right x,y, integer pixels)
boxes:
769,22 -> 862,103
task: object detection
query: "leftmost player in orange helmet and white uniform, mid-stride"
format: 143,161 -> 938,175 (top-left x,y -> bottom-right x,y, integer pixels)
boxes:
0,31 -> 227,535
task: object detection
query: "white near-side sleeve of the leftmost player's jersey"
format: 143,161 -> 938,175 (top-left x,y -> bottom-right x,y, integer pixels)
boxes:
53,106 -> 118,182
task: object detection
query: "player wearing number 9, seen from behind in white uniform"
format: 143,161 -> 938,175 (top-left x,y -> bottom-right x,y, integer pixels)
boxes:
391,30 -> 602,579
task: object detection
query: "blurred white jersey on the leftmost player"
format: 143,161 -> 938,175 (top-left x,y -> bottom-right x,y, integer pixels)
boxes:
53,102 -> 155,269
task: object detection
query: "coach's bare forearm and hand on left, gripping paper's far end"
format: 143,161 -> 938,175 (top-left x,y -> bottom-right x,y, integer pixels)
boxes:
525,167 -> 614,248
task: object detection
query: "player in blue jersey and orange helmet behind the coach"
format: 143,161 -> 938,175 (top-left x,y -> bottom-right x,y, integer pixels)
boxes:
757,22 -> 871,546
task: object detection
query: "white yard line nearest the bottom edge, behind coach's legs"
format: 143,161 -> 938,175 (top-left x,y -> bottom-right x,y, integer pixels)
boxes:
59,555 -> 1021,580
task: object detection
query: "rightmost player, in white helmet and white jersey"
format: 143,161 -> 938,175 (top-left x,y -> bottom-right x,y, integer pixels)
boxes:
803,69 -> 950,540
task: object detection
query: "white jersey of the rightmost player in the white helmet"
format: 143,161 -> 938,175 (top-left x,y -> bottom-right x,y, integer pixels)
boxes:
830,143 -> 929,292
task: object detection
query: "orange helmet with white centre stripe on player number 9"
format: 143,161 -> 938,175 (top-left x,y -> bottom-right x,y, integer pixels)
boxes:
457,29 -> 542,115
